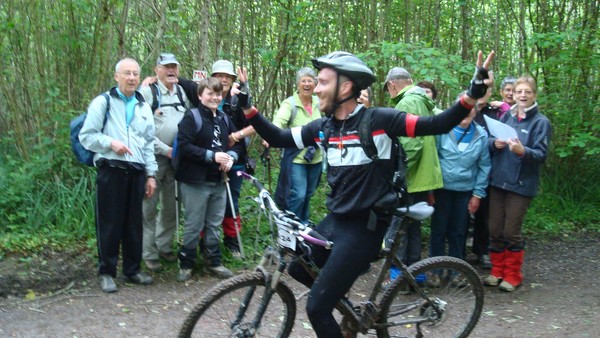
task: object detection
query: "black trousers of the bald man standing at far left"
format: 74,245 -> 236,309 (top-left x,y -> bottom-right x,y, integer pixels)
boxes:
96,161 -> 146,277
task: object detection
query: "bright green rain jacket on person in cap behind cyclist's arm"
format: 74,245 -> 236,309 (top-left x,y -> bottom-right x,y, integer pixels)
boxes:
390,85 -> 444,193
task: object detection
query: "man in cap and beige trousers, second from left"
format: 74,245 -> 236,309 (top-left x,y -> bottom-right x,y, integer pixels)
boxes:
140,53 -> 192,272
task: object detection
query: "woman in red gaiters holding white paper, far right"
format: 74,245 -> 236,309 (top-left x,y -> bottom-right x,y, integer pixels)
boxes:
483,76 -> 552,292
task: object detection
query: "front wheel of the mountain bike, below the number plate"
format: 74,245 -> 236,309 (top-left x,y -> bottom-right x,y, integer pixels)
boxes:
179,272 -> 296,337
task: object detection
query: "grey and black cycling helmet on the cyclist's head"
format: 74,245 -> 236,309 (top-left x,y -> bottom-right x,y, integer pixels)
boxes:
312,52 -> 376,91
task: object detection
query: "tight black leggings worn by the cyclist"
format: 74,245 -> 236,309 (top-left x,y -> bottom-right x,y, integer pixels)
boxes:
289,214 -> 390,338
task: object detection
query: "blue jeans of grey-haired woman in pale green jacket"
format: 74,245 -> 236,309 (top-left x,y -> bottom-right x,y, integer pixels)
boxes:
287,163 -> 322,223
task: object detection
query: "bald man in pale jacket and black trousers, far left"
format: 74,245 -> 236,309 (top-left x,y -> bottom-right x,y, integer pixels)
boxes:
79,58 -> 158,292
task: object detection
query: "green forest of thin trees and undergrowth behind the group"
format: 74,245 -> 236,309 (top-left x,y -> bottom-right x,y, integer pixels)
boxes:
0,0 -> 600,259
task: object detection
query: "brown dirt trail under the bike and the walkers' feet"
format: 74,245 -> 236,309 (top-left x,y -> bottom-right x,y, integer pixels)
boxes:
0,233 -> 600,338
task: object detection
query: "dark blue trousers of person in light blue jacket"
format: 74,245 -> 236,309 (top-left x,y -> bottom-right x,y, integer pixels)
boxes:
429,189 -> 472,259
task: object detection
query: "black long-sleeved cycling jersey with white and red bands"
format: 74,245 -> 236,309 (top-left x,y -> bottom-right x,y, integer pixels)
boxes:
250,103 -> 470,214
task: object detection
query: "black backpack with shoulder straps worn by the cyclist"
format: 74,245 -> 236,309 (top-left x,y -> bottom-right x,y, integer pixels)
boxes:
321,108 -> 410,213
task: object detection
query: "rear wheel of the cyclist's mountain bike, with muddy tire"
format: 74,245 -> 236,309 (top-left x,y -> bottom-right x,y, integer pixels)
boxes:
377,256 -> 484,338
